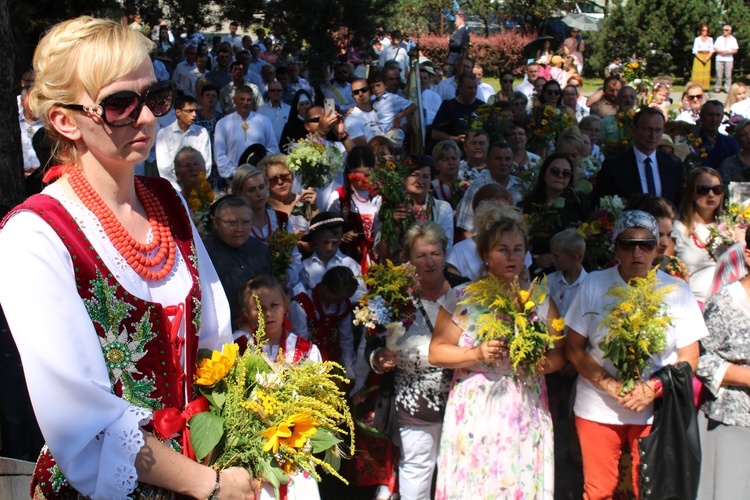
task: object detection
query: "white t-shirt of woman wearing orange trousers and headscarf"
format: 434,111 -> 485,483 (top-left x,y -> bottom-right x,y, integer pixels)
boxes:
565,266 -> 708,425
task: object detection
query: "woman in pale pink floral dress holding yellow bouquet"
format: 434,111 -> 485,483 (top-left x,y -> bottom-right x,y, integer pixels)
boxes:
429,205 -> 565,499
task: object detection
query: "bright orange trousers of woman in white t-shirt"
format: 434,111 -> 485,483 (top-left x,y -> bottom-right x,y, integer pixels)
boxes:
576,417 -> 651,500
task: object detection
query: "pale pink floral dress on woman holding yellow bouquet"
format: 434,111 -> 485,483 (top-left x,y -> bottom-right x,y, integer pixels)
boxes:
435,286 -> 554,500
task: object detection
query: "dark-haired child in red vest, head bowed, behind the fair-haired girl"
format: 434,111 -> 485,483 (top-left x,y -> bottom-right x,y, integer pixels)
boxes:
290,266 -> 357,379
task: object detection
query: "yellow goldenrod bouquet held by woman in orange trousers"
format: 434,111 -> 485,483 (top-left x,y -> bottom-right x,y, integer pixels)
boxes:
599,267 -> 674,396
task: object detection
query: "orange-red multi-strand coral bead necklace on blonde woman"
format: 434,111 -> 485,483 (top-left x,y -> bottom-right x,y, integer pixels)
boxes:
68,169 -> 176,281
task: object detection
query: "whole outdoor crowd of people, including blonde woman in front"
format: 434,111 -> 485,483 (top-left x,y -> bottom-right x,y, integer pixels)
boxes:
0,10 -> 750,500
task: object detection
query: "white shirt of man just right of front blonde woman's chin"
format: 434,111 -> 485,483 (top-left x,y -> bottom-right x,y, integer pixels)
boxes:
156,120 -> 213,193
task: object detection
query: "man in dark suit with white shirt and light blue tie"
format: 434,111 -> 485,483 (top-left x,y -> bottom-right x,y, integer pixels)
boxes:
594,108 -> 683,206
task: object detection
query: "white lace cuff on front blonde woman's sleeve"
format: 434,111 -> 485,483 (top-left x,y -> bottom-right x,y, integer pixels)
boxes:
99,406 -> 152,500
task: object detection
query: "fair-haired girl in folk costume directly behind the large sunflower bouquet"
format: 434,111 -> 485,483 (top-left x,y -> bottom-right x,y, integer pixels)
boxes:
234,275 -> 322,500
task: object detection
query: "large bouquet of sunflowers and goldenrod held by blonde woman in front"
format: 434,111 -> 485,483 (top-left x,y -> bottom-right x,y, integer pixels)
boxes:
189,297 -> 354,498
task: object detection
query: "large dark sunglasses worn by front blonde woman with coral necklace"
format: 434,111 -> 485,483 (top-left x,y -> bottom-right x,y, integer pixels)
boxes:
58,81 -> 175,127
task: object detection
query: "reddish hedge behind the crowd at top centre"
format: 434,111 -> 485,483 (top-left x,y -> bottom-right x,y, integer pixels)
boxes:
419,31 -> 536,76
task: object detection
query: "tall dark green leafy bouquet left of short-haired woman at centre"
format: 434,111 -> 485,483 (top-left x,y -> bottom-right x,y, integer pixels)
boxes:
370,161 -> 411,248
